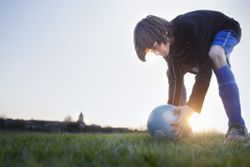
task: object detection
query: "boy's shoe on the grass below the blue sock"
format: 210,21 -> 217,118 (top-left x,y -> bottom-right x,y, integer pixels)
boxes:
226,126 -> 248,141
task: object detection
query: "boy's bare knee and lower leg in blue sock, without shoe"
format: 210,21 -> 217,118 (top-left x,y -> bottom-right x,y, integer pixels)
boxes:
210,45 -> 245,127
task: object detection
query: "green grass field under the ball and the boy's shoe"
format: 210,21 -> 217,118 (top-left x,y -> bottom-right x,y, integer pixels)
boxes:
0,131 -> 250,167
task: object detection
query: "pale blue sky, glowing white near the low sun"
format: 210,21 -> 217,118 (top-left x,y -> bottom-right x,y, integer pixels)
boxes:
0,0 -> 250,132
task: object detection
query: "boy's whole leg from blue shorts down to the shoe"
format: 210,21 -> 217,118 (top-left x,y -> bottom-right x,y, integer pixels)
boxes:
209,30 -> 247,140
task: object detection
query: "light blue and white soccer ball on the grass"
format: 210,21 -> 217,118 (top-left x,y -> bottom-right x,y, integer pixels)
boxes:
147,104 -> 178,140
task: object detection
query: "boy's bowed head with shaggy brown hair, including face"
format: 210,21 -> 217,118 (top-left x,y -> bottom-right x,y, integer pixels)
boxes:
134,15 -> 173,61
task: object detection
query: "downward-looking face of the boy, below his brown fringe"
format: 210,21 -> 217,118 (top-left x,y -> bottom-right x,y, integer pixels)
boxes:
148,42 -> 170,57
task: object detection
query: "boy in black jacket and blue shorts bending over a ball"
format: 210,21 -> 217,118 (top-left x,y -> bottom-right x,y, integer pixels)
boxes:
134,10 -> 248,141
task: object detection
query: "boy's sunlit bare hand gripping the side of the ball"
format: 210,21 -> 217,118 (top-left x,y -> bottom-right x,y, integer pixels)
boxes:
172,105 -> 194,138
